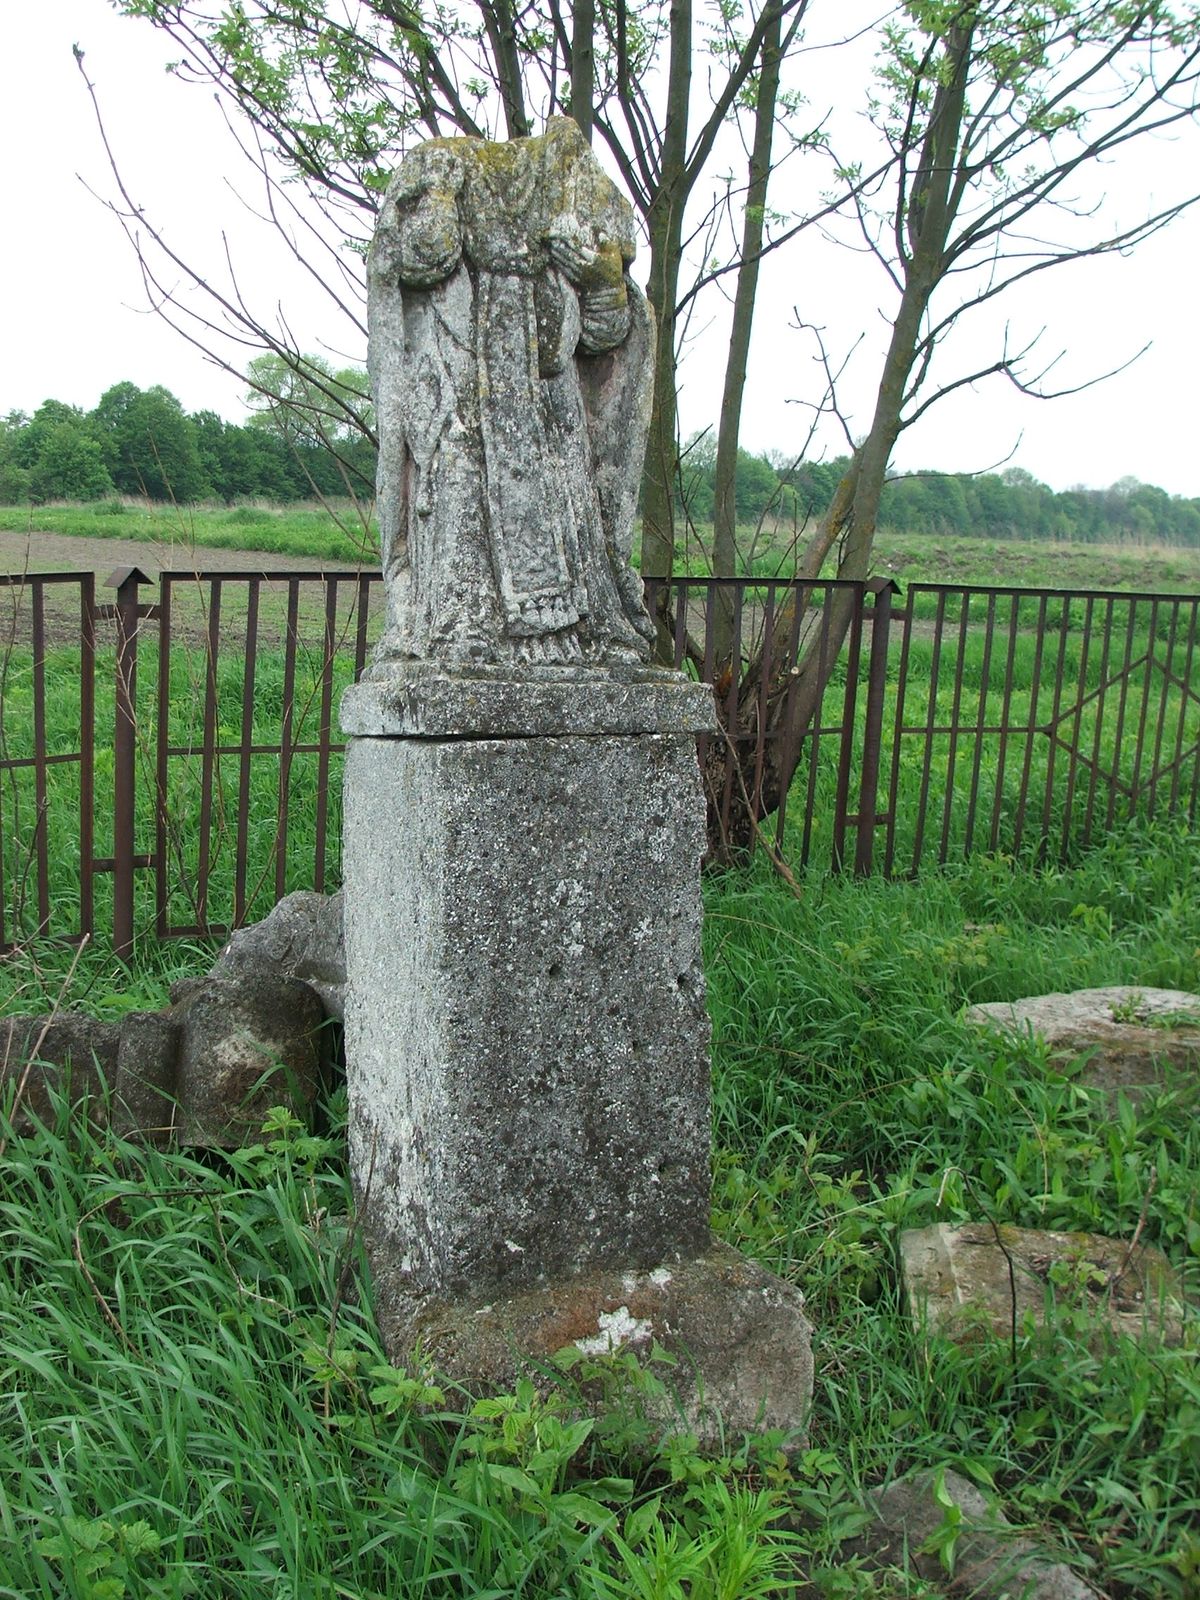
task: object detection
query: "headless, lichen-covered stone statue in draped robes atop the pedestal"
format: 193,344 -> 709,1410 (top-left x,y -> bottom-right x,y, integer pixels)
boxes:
368,117 -> 653,678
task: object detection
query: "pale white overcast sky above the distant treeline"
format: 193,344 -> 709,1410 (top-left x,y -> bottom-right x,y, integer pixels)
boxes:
0,0 -> 1200,496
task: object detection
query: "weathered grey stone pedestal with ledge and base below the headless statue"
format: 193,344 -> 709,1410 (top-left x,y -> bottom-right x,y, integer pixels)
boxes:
342,670 -> 811,1437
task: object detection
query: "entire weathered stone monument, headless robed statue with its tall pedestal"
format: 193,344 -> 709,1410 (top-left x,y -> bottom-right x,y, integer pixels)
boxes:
341,118 -> 811,1426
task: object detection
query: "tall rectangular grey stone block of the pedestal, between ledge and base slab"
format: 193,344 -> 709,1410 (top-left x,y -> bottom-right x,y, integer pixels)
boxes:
344,734 -> 710,1294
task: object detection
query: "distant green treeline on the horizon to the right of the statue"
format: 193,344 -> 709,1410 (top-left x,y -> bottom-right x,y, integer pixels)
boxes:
678,440 -> 1200,546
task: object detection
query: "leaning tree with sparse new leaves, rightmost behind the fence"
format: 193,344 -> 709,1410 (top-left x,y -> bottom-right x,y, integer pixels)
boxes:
712,0 -> 1200,854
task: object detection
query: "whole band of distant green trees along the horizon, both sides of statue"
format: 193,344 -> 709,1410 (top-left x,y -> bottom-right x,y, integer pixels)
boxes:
0,374 -> 1200,546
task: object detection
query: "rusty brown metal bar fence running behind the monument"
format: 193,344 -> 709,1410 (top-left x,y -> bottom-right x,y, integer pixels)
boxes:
0,568 -> 1200,954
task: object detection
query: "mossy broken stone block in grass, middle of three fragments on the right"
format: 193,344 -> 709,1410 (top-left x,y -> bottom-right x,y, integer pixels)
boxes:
899,1222 -> 1184,1342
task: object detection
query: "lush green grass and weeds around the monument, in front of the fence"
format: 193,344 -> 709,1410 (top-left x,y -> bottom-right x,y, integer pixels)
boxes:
0,827 -> 1200,1600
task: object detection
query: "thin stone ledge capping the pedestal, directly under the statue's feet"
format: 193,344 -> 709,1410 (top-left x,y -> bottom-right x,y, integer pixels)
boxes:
341,662 -> 717,739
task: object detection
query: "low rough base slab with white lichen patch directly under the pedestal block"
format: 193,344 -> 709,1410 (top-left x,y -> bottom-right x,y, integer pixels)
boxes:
368,1243 -> 813,1450
